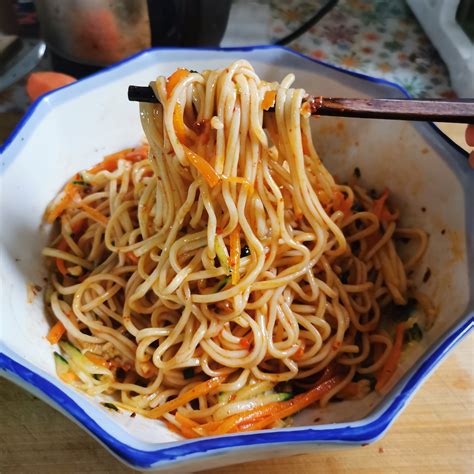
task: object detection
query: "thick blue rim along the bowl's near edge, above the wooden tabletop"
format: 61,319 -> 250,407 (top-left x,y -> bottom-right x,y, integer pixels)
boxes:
0,312 -> 474,469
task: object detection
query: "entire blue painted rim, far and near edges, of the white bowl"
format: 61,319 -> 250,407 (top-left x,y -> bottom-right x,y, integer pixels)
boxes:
0,45 -> 474,468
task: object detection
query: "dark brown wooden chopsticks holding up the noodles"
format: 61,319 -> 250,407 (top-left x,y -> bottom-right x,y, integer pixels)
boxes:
128,86 -> 474,123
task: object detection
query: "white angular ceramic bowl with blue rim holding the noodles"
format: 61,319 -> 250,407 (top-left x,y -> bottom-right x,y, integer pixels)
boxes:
0,47 -> 474,472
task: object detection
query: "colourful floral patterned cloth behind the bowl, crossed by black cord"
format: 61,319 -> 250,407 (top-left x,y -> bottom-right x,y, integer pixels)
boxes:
224,0 -> 454,97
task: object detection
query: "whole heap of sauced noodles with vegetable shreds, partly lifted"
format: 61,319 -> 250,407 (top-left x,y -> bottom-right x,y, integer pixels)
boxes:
43,61 -> 434,437
